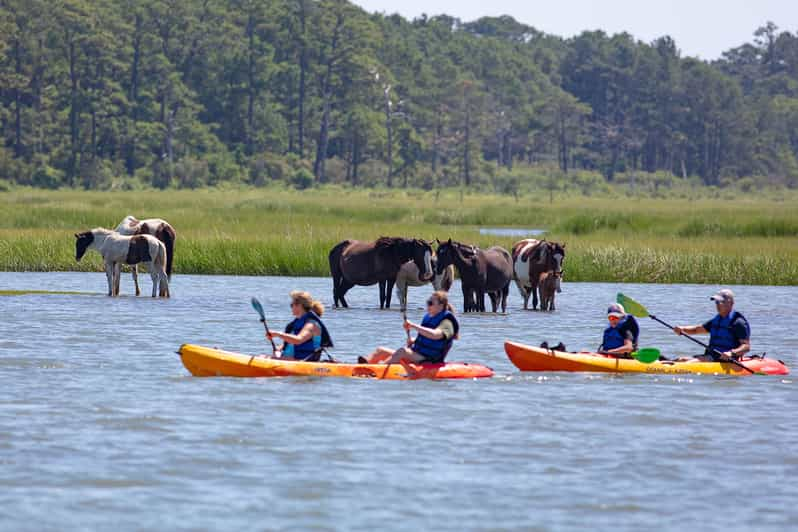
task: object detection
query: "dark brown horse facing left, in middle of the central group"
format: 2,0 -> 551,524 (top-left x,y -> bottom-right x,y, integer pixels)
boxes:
436,238 -> 513,312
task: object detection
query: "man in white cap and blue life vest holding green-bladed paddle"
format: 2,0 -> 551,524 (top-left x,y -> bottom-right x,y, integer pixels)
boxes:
673,288 -> 751,362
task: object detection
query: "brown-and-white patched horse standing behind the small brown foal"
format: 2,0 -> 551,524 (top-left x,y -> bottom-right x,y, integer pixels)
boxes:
513,238 -> 565,310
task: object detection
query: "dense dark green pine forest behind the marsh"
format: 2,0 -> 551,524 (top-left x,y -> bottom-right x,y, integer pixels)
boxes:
0,0 -> 798,188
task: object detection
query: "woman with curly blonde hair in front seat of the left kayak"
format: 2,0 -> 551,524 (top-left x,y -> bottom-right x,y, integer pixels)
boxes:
266,290 -> 333,362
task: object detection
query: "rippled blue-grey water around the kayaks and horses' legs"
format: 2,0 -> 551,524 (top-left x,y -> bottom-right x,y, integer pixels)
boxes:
0,273 -> 798,531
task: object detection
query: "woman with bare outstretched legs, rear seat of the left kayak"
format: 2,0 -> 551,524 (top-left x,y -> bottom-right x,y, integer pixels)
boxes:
358,290 -> 460,364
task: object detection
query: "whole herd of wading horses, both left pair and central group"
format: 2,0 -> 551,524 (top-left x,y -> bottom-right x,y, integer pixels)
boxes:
75,216 -> 565,312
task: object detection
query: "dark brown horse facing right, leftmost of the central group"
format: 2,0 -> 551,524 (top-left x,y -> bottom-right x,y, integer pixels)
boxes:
328,236 -> 433,309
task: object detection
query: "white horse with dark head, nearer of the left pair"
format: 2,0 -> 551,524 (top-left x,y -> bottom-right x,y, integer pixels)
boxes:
75,227 -> 169,297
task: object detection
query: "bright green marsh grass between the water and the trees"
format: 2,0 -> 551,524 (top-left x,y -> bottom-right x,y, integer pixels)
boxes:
0,187 -> 798,285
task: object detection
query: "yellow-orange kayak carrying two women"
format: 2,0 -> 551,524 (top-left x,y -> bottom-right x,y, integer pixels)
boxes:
178,344 -> 493,380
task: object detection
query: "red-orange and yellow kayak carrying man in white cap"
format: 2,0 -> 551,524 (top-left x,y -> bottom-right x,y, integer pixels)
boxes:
504,341 -> 790,376
